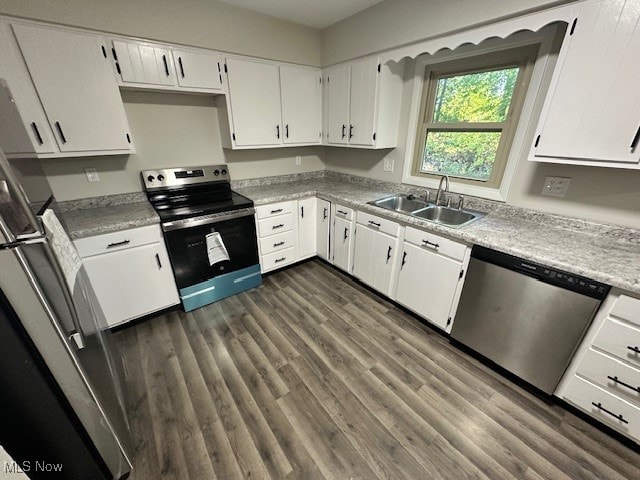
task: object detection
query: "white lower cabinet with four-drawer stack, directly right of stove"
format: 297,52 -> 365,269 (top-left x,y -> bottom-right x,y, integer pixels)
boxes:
256,197 -> 316,273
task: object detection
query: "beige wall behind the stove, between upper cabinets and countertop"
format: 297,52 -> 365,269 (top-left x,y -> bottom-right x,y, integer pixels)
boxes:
41,91 -> 324,200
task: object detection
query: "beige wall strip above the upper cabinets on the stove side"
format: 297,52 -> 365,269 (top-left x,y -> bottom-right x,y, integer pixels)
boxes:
0,0 -> 321,66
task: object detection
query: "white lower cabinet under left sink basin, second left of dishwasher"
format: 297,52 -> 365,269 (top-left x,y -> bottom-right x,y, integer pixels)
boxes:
352,212 -> 400,297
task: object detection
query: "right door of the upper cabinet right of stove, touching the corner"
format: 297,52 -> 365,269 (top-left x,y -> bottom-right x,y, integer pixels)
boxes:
280,65 -> 322,144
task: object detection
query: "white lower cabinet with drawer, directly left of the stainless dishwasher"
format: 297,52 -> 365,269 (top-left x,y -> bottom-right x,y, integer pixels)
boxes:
395,227 -> 470,332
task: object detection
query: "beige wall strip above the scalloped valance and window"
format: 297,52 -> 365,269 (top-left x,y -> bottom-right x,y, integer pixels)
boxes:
322,0 -> 571,66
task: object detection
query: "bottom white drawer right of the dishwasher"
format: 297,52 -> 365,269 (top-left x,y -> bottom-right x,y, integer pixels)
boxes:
564,376 -> 640,439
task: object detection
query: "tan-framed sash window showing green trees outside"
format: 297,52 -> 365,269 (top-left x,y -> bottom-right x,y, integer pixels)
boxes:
412,45 -> 538,188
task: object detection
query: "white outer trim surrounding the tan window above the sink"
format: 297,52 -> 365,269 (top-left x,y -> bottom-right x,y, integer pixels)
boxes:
402,25 -> 564,202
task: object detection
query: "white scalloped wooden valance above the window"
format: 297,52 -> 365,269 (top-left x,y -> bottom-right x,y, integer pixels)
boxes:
380,2 -> 583,63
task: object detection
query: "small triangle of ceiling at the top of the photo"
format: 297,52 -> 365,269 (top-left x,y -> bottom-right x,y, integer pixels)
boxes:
219,0 -> 382,28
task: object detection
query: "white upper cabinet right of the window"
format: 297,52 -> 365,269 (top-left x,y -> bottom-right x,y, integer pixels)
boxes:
530,0 -> 640,168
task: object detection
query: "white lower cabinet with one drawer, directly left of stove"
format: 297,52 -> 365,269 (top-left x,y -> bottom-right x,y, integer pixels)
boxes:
75,225 -> 180,327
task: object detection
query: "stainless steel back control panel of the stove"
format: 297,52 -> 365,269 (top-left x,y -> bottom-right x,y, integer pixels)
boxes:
141,165 -> 231,190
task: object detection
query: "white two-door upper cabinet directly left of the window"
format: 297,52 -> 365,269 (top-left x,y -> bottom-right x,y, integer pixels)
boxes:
323,57 -> 404,148
